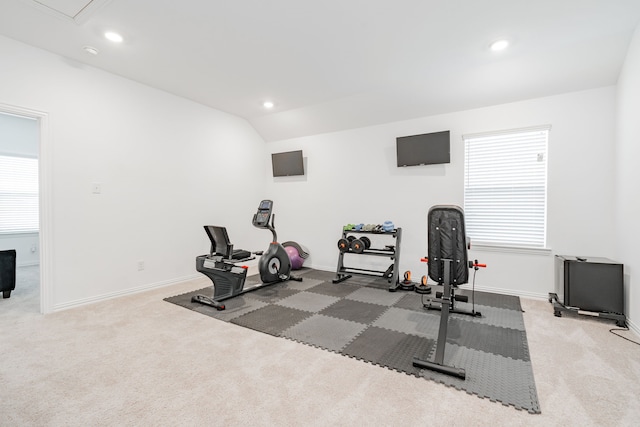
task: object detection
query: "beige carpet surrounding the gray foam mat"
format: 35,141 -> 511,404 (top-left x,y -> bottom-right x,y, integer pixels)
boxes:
0,267 -> 640,426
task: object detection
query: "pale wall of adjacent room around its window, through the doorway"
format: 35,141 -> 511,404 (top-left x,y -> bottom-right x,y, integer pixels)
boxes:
0,113 -> 39,266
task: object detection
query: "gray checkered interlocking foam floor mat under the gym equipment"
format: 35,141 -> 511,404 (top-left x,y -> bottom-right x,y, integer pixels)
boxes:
165,269 -> 540,414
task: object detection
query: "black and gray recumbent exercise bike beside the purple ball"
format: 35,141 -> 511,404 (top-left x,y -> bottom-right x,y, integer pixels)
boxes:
191,200 -> 302,310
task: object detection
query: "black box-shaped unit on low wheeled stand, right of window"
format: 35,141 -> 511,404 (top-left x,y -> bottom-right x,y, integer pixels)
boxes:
549,255 -> 626,327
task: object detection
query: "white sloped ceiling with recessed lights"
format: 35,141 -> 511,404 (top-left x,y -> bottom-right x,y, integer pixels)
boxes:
0,0 -> 640,141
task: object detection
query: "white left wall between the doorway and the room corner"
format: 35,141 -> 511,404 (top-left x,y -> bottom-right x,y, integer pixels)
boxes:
0,37 -> 268,309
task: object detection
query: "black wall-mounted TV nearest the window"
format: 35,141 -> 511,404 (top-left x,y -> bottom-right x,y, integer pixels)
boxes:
396,130 -> 451,167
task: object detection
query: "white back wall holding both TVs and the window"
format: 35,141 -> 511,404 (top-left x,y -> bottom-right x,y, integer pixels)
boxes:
266,87 -> 615,298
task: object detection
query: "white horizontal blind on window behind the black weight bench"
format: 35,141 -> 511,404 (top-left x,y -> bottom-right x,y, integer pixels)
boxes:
464,127 -> 549,248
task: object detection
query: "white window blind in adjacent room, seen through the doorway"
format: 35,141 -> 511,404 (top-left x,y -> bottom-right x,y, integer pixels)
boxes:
0,156 -> 39,234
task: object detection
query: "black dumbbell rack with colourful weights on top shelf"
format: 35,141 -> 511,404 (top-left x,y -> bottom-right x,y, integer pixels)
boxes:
333,228 -> 402,292
